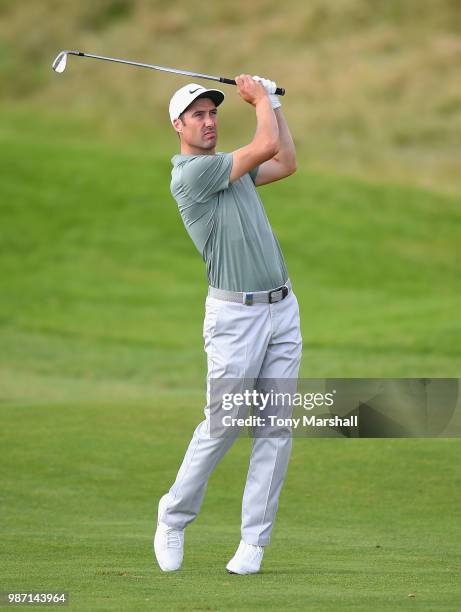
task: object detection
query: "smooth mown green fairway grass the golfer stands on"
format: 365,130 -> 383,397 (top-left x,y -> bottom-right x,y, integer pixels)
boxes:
0,108 -> 461,610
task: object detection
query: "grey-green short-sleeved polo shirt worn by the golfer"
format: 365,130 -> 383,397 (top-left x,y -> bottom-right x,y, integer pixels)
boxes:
171,153 -> 288,291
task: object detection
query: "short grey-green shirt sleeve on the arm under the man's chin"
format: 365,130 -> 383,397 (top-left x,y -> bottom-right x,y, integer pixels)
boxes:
181,153 -> 232,202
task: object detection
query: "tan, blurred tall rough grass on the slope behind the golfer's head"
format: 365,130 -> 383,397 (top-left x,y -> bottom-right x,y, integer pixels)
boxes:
0,0 -> 461,191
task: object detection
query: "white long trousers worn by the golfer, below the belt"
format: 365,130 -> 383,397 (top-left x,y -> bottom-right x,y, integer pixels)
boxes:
160,291 -> 302,546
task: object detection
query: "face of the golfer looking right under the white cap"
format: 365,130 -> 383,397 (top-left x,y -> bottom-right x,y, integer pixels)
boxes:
174,98 -> 218,152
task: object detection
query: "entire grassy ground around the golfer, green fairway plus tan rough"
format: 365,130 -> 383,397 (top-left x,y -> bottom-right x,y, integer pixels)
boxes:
0,0 -> 461,611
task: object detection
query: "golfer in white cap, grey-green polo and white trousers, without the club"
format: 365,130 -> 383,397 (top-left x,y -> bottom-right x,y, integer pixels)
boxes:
154,74 -> 302,574
